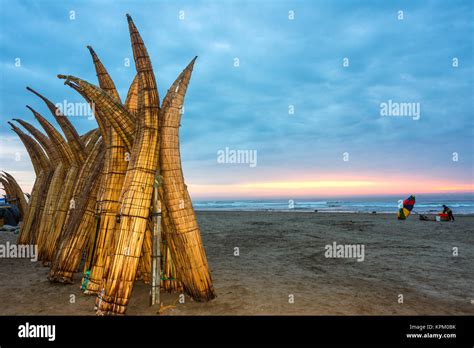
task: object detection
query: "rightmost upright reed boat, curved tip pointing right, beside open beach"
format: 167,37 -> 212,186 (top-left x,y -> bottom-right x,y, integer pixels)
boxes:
160,59 -> 215,301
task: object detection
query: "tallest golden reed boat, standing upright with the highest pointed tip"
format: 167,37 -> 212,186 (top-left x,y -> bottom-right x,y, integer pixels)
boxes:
99,16 -> 159,314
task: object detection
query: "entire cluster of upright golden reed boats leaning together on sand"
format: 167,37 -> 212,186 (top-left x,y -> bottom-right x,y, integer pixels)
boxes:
0,15 -> 215,315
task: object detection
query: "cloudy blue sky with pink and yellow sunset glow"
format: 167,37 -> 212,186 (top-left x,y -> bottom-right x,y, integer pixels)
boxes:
0,0 -> 474,199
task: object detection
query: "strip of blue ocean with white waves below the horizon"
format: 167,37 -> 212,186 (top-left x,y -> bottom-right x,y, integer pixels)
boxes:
193,194 -> 474,215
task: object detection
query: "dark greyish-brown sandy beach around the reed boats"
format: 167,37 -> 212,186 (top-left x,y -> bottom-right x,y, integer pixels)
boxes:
0,212 -> 474,315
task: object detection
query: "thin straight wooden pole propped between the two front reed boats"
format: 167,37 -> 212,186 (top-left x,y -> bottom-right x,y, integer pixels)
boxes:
150,170 -> 161,306
